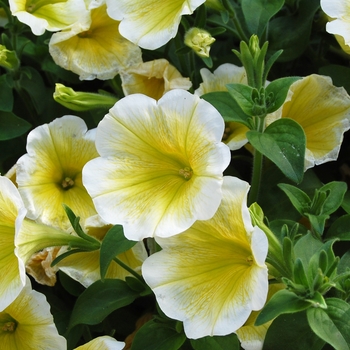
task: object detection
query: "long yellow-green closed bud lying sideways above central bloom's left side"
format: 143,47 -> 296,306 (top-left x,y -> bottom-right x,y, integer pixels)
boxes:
53,84 -> 118,112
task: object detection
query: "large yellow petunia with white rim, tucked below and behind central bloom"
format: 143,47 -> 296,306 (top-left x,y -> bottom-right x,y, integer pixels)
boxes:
142,177 -> 268,339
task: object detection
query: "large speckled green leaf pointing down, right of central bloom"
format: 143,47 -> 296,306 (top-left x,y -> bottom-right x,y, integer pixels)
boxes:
247,118 -> 306,183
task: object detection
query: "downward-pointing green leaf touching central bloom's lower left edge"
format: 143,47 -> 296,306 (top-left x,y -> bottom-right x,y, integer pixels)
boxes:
100,225 -> 137,280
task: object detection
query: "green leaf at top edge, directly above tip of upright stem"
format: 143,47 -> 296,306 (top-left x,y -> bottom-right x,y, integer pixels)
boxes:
242,0 -> 284,37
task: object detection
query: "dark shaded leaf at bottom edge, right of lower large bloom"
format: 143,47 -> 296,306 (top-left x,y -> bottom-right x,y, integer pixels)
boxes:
263,312 -> 325,350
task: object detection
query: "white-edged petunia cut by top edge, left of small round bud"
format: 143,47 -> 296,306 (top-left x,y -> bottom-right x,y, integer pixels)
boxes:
106,0 -> 205,50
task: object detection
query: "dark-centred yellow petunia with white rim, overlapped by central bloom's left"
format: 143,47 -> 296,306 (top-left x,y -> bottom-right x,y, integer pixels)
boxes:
16,116 -> 98,229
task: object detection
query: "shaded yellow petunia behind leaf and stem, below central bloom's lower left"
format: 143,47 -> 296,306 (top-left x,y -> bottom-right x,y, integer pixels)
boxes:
57,215 -> 147,288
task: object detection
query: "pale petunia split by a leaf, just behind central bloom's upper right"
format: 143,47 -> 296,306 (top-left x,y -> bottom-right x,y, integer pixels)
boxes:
194,63 -> 249,150
